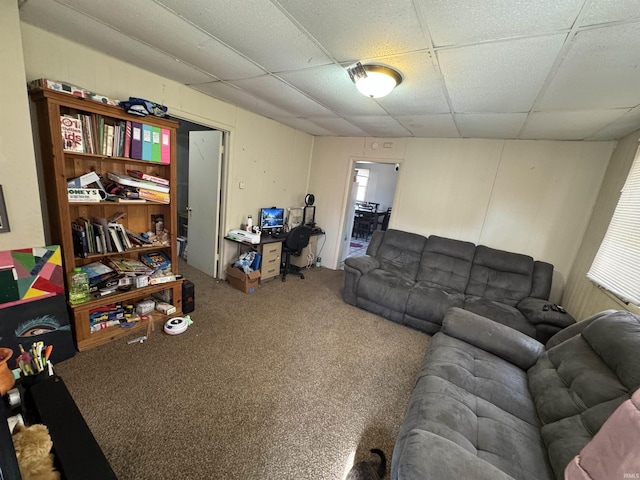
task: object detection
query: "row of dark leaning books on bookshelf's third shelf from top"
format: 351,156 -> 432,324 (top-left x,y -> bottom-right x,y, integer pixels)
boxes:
71,214 -> 151,258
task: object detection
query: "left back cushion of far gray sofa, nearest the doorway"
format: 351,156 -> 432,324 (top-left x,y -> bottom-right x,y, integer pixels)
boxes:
376,230 -> 427,281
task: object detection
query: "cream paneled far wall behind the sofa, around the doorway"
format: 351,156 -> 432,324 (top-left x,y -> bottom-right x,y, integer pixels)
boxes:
310,137 -> 615,301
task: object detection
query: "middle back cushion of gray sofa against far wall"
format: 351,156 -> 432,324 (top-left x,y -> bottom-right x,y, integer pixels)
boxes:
416,235 -> 476,293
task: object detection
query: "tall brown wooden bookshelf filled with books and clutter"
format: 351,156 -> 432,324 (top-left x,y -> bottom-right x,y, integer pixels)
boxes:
30,89 -> 182,350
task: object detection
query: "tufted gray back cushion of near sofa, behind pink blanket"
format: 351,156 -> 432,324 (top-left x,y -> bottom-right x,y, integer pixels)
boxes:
527,311 -> 640,478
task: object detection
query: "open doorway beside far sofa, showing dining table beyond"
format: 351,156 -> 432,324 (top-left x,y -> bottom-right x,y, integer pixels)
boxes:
340,159 -> 399,268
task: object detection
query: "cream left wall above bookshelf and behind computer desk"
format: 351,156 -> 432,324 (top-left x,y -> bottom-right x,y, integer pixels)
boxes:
21,21 -> 313,270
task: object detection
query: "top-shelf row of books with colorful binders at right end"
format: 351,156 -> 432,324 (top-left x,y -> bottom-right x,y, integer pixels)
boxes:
60,113 -> 171,163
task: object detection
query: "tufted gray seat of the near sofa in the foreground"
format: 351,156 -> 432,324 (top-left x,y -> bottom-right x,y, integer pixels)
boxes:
397,333 -> 551,479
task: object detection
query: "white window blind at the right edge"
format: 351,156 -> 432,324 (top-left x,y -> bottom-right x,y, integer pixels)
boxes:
587,144 -> 640,305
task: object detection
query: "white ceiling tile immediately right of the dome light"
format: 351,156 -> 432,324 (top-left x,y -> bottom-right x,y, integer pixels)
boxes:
437,34 -> 565,113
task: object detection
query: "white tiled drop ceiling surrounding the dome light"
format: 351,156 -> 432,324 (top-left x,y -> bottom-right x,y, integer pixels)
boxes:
20,0 -> 640,140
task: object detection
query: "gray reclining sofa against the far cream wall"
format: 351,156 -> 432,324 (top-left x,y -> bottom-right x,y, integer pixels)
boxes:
343,230 -> 575,343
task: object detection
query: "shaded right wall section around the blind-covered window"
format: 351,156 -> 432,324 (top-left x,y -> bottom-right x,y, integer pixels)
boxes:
562,130 -> 640,320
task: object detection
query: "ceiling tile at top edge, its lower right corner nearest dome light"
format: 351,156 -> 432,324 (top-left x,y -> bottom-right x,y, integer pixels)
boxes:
157,0 -> 331,72
